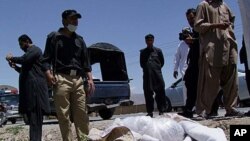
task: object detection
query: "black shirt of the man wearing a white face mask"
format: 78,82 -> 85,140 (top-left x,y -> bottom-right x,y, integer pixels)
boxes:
43,28 -> 91,72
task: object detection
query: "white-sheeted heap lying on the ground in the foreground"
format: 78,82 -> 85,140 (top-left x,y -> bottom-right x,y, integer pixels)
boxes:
88,114 -> 226,141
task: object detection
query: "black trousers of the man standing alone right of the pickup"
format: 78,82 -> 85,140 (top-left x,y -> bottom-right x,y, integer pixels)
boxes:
144,88 -> 166,113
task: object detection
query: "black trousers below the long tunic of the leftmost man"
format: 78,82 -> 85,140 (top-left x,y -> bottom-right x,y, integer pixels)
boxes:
27,108 -> 43,141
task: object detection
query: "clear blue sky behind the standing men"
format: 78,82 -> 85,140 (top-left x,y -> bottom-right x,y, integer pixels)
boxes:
0,0 -> 244,94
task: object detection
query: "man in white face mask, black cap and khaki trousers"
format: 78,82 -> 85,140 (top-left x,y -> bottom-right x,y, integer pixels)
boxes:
44,9 -> 95,141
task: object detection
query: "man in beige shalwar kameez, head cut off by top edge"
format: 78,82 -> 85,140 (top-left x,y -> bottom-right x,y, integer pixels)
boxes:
194,0 -> 242,116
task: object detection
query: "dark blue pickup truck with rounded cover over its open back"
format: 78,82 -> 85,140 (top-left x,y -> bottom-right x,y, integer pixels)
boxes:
47,43 -> 133,119
